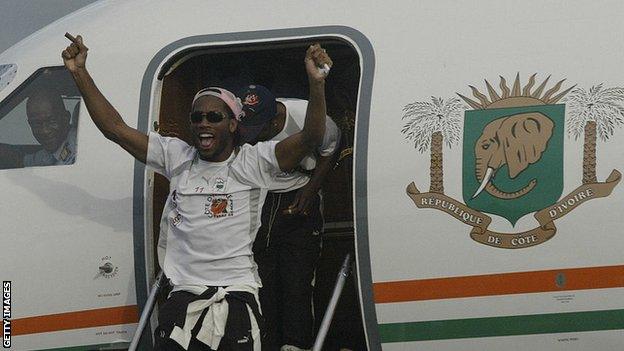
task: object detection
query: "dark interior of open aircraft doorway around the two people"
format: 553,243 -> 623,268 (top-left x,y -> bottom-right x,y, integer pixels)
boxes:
152,38 -> 366,350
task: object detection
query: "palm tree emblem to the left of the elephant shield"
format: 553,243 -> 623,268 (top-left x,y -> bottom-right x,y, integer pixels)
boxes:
401,96 -> 464,193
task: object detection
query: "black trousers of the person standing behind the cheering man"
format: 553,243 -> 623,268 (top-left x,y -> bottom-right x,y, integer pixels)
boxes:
253,190 -> 323,351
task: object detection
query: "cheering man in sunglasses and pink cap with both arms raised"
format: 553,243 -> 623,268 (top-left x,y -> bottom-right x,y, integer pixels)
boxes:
62,34 -> 331,350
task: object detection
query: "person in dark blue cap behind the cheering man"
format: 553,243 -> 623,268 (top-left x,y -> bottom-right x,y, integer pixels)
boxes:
238,85 -> 340,351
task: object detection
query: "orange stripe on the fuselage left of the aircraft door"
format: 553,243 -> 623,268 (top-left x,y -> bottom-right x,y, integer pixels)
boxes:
11,305 -> 139,335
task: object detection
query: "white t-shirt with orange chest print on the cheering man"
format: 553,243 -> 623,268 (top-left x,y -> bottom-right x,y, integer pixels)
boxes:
147,133 -> 285,286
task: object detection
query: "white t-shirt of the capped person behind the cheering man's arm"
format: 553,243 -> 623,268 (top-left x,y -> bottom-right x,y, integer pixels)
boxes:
271,98 -> 340,192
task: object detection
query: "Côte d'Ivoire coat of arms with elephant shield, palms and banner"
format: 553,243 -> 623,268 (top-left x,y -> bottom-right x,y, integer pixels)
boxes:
401,74 -> 624,249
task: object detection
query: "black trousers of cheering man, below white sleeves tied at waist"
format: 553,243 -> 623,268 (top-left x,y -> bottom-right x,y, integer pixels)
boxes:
154,287 -> 264,351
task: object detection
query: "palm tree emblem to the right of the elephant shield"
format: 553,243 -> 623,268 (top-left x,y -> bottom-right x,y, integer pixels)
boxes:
566,84 -> 624,184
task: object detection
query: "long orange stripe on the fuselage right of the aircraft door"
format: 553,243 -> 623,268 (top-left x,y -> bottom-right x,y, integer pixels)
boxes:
373,266 -> 624,303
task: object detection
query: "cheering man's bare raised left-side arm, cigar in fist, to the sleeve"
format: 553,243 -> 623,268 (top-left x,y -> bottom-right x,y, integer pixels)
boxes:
62,33 -> 149,163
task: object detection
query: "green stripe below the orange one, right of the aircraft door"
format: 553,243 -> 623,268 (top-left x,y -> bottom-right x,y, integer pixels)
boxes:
379,310 -> 624,343
